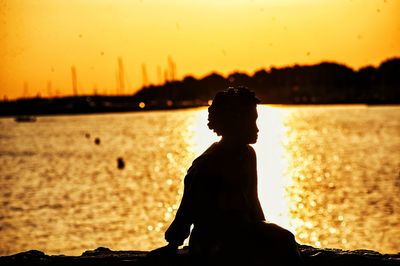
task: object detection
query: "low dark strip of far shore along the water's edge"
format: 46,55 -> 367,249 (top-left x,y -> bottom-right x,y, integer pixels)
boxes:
0,92 -> 400,117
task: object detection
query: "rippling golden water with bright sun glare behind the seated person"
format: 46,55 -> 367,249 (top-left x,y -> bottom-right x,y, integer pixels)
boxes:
0,105 -> 400,255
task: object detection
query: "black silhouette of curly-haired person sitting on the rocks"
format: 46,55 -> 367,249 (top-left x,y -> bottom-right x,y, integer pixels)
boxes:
150,88 -> 301,265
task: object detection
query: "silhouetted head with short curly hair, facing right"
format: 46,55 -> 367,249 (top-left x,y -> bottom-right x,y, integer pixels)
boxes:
208,87 -> 260,144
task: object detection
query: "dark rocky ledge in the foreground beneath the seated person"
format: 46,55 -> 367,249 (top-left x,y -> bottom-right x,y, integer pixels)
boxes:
0,245 -> 400,266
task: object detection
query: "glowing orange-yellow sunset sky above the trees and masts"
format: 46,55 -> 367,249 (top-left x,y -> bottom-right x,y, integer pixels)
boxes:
0,0 -> 400,98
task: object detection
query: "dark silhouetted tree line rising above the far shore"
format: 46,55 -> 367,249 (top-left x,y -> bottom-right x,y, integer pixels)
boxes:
134,58 -> 400,106
